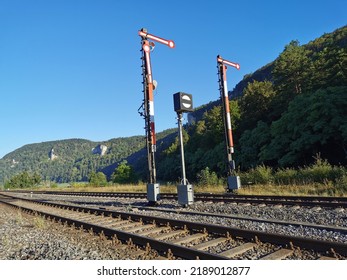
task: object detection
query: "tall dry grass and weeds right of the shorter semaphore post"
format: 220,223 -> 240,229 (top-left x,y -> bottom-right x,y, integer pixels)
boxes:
237,158 -> 347,196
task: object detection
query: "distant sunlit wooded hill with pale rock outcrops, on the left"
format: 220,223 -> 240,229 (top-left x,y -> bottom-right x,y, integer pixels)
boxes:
0,130 -> 176,183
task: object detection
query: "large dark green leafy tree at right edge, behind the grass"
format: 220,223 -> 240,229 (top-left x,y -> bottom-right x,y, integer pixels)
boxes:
260,87 -> 347,166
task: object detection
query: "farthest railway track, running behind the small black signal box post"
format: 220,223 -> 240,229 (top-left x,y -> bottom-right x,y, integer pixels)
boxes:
6,191 -> 347,208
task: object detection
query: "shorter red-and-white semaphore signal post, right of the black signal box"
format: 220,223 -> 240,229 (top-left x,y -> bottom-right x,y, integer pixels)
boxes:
217,55 -> 241,190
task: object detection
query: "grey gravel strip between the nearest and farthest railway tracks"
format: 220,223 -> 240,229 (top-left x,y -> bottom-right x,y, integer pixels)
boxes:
20,194 -> 347,243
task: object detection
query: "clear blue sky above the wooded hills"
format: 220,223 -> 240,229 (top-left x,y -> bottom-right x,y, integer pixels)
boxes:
0,0 -> 347,158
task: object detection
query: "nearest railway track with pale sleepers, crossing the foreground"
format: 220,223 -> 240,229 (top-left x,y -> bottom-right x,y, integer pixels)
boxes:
0,194 -> 347,259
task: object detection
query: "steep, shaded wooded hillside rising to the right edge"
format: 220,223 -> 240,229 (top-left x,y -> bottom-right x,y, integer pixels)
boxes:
158,26 -> 347,180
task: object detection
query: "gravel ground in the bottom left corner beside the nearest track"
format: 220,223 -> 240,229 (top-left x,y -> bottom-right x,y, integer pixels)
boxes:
0,204 -> 149,260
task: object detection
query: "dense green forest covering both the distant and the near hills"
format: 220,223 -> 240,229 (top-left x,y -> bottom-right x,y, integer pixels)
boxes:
0,26 -> 347,183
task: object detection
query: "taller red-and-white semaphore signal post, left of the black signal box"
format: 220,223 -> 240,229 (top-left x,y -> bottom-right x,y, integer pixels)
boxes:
138,28 -> 175,204
